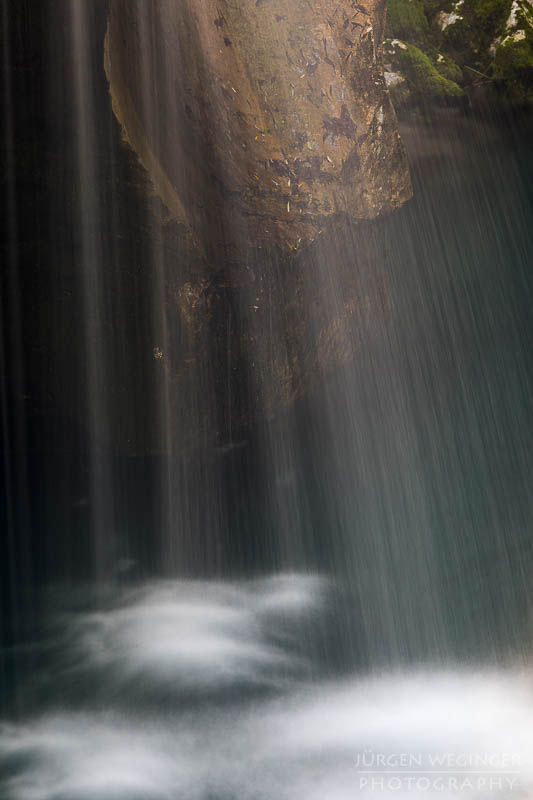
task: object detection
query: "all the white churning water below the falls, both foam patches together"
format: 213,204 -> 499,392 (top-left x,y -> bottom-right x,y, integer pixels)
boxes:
0,575 -> 533,800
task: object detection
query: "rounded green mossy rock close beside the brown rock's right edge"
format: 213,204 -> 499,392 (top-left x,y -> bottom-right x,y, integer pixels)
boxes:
385,39 -> 463,106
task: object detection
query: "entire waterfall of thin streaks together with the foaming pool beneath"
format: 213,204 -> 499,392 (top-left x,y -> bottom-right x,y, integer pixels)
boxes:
0,0 -> 533,800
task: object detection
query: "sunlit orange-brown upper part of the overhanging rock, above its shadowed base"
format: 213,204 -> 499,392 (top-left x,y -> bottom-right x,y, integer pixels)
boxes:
106,0 -> 410,259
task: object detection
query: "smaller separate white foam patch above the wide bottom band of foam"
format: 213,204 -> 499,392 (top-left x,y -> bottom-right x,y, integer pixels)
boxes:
54,576 -> 326,692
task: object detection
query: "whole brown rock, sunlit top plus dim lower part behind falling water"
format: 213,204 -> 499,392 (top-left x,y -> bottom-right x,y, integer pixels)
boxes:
105,0 -> 411,439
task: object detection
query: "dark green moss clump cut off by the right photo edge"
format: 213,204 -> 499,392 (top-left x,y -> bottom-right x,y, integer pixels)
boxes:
493,31 -> 533,103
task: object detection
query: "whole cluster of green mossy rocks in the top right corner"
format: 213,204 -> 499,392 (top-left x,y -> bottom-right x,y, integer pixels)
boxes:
385,0 -> 533,112
